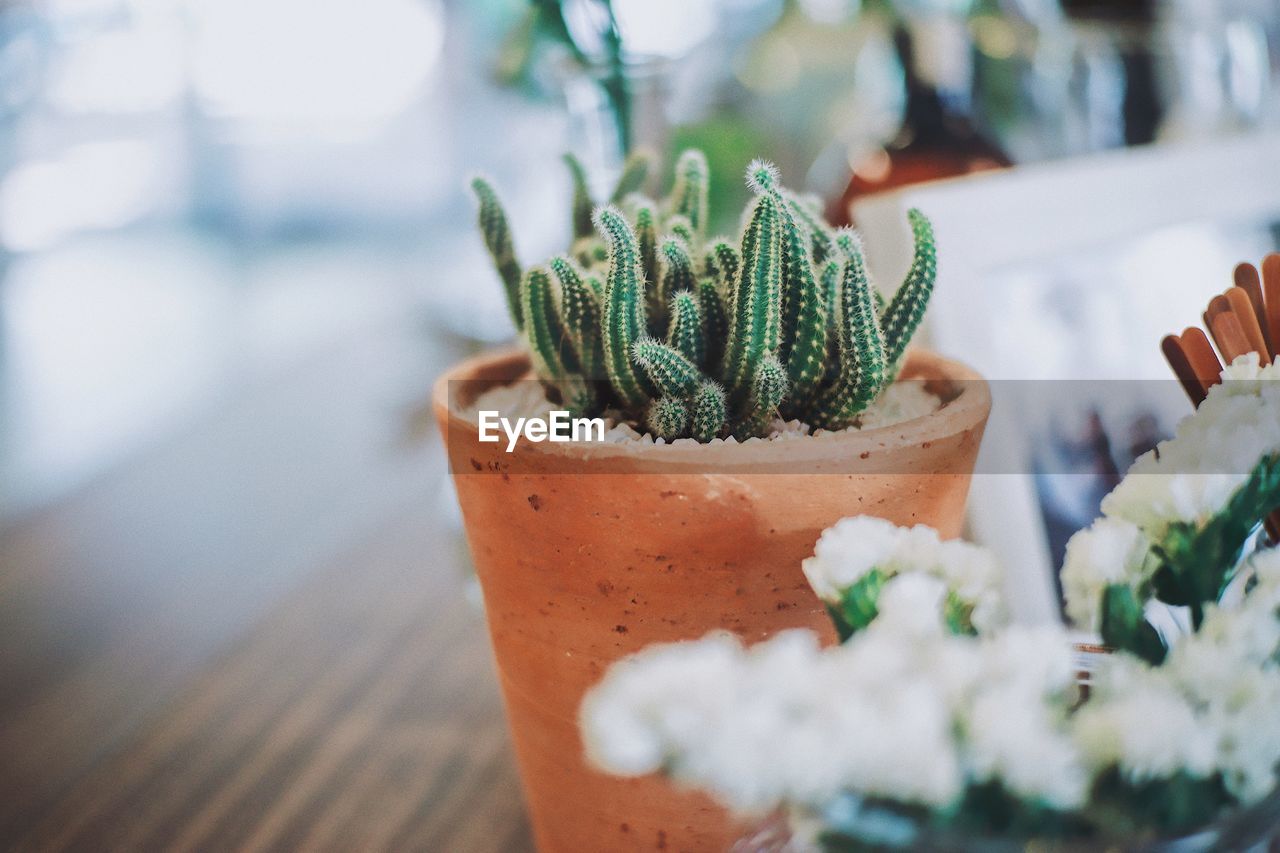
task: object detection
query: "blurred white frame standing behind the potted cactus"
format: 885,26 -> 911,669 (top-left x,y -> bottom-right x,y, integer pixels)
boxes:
854,132 -> 1280,621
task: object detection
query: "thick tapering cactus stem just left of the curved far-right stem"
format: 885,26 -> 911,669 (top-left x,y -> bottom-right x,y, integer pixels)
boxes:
812,231 -> 886,429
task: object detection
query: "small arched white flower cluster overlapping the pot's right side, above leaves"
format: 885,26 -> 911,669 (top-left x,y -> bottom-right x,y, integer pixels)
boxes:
801,515 -> 1007,631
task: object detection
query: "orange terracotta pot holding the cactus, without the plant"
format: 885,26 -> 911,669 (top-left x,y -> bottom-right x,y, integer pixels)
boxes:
434,351 -> 991,853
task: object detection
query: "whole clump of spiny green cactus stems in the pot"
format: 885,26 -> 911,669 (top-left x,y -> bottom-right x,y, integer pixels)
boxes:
472,151 -> 937,442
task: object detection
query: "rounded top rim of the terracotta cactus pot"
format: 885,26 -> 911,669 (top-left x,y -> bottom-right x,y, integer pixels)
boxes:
431,347 -> 991,465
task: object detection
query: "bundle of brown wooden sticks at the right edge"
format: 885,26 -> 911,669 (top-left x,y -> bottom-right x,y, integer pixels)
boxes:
1161,254 -> 1280,542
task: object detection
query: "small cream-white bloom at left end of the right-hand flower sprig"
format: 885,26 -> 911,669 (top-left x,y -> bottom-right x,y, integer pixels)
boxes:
1061,519 -> 1151,631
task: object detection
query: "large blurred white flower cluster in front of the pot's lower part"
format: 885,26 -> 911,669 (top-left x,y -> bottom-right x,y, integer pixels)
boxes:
582,604 -> 1088,813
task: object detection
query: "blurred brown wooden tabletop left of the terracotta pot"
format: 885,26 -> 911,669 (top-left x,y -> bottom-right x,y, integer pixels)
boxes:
0,330 -> 530,853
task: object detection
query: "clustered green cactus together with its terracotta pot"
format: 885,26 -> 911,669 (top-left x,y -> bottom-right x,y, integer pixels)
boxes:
435,151 -> 991,853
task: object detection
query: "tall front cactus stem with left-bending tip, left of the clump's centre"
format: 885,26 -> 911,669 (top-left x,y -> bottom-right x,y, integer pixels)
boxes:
595,206 -> 649,409
